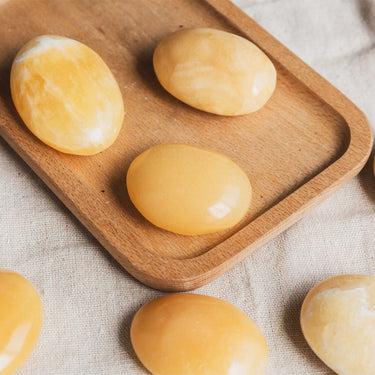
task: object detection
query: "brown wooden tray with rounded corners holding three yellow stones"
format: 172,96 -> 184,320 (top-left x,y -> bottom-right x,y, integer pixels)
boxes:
0,0 -> 372,291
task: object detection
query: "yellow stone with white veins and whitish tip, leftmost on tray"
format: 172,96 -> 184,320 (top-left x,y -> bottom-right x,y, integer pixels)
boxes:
10,35 -> 124,155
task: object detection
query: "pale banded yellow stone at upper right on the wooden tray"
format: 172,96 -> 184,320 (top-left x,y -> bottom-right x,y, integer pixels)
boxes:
153,28 -> 276,116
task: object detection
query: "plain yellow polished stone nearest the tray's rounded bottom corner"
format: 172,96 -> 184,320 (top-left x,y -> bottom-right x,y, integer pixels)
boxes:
126,144 -> 251,235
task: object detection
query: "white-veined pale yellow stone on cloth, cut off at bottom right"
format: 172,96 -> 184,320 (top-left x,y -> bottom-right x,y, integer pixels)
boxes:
301,275 -> 375,375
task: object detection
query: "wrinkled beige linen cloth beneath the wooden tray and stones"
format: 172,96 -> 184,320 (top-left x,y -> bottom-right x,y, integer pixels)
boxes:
0,0 -> 375,375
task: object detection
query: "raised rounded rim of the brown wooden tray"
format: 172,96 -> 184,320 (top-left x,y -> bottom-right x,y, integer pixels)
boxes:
0,0 -> 373,291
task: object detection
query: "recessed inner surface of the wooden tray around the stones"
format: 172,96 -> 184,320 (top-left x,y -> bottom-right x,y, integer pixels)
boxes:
0,0 -> 350,259
